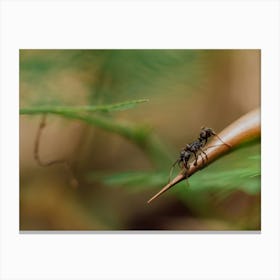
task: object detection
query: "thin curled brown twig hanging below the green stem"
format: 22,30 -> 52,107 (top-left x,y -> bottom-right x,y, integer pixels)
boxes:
34,114 -> 79,187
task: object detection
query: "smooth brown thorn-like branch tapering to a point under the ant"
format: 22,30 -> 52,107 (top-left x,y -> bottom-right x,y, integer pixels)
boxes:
147,108 -> 261,203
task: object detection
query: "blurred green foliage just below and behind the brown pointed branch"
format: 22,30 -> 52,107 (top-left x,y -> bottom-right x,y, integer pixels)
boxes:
89,141 -> 261,196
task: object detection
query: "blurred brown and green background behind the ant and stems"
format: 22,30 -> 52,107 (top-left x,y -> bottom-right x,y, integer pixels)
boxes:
20,50 -> 261,230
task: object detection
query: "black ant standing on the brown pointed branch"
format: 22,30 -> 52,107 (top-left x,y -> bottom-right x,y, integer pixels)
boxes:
169,127 -> 231,181
